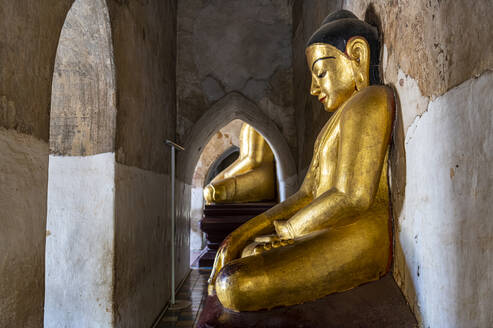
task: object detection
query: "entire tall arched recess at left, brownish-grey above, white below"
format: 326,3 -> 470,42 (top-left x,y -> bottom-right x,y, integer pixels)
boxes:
44,0 -> 116,327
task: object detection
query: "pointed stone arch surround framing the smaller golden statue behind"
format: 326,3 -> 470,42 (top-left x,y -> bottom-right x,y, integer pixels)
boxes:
178,93 -> 297,268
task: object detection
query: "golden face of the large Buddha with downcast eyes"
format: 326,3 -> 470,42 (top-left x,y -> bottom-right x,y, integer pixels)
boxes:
306,38 -> 369,112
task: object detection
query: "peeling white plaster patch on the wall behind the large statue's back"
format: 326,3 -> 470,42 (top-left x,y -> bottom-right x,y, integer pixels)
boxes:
395,72 -> 493,328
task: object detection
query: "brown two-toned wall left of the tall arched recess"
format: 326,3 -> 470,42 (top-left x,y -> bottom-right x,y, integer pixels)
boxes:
0,0 -> 72,327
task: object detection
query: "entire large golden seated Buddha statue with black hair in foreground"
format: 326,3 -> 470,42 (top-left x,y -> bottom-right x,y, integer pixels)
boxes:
209,11 -> 394,311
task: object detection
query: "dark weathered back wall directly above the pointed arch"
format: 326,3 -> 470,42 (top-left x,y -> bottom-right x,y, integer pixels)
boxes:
177,0 -> 296,159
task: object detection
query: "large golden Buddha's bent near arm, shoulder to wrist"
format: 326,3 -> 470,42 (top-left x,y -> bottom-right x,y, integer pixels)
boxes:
275,95 -> 392,238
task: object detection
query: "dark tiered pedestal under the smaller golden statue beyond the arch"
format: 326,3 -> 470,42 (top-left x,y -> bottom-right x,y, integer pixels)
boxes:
199,203 -> 275,268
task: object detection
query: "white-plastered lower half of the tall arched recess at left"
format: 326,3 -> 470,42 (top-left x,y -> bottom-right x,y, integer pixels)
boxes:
44,153 -> 115,328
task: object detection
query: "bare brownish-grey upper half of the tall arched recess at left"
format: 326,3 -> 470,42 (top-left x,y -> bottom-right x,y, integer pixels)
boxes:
50,0 -> 116,156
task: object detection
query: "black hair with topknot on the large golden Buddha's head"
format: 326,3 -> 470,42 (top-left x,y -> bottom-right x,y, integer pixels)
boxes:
306,10 -> 382,84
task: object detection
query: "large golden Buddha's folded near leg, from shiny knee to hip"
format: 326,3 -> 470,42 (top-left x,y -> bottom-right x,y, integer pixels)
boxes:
216,216 -> 390,311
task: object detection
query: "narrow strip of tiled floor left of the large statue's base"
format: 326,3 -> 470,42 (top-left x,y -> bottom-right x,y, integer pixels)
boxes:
157,270 -> 210,328
